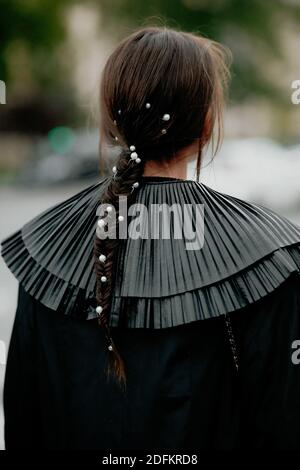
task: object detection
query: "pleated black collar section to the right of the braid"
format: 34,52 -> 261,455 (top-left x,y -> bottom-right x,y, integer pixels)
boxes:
111,180 -> 300,328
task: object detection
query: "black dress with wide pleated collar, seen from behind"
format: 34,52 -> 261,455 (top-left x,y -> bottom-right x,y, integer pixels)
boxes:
2,177 -> 300,451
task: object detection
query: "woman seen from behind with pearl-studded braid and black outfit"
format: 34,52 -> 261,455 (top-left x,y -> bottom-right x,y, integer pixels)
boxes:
2,27 -> 300,451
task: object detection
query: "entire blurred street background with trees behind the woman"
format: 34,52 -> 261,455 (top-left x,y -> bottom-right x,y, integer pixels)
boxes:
0,0 -> 300,449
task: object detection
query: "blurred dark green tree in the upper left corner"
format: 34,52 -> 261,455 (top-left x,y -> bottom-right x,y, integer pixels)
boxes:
0,0 -> 78,133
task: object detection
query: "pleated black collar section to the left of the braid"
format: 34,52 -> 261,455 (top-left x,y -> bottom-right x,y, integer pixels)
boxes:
1,178 -> 107,318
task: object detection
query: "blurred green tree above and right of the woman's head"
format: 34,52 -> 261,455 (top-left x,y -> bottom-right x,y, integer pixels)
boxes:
99,0 -> 300,103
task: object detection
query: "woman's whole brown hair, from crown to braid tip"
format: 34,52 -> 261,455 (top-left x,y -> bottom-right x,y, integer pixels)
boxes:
94,26 -> 231,385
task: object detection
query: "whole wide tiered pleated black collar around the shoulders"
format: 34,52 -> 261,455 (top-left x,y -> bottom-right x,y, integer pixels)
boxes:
2,177 -> 300,328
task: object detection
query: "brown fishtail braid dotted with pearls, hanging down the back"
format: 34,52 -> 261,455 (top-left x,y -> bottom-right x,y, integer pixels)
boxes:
94,149 -> 144,386
